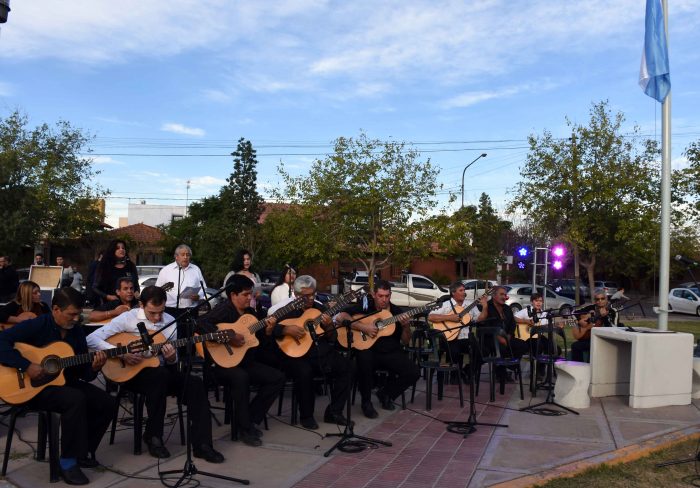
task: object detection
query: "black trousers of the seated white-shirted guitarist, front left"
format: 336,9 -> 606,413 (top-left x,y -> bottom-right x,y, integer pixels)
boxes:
124,366 -> 212,446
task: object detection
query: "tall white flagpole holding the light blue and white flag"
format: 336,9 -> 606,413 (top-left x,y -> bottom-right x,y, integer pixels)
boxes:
658,0 -> 671,330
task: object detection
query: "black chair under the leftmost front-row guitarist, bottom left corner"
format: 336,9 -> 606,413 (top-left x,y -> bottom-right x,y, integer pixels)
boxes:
0,405 -> 61,483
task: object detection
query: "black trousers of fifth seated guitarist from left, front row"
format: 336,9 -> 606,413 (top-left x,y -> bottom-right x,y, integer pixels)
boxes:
356,348 -> 420,403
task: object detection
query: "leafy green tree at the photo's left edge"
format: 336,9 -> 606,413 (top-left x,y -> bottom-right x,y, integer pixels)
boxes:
0,111 -> 106,254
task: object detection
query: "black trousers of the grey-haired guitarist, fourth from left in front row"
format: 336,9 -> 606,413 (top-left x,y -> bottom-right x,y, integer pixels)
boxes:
256,340 -> 354,419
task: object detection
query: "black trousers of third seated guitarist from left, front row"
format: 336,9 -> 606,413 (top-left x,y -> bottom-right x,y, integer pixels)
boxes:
214,359 -> 284,430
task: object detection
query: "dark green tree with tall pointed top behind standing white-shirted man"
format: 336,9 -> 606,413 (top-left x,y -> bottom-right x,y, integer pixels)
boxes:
162,138 -> 264,283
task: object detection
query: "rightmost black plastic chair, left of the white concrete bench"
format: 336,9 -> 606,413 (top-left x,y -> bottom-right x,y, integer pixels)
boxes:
475,325 -> 525,402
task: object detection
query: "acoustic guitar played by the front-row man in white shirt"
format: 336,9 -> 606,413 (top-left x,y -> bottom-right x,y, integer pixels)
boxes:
102,330 -> 233,383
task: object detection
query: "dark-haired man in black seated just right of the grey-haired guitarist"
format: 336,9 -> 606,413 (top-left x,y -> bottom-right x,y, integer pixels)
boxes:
336,280 -> 420,419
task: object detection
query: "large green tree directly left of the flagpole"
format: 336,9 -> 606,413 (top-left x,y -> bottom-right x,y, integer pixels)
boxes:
510,101 -> 659,286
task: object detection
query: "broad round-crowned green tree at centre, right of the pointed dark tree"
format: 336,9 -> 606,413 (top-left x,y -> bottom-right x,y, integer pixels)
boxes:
275,134 -> 438,288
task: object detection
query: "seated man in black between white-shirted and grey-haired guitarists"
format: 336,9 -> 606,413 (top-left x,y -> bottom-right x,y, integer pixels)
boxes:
197,274 -> 284,447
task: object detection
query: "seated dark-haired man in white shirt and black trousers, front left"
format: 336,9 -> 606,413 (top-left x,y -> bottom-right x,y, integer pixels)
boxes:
87,286 -> 224,463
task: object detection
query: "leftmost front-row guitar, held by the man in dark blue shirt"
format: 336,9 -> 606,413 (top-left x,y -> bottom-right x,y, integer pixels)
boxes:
0,336 -> 144,405
